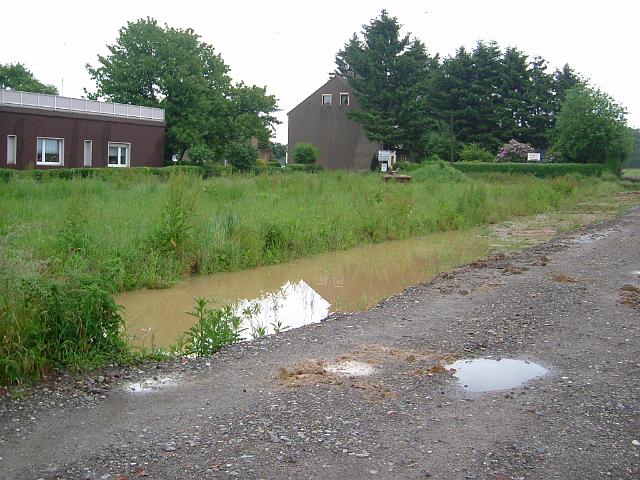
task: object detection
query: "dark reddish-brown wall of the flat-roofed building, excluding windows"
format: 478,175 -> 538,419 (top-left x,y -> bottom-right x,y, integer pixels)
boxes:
0,107 -> 165,169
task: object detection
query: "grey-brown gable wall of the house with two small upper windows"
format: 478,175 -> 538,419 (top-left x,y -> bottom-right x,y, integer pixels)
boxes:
287,77 -> 379,170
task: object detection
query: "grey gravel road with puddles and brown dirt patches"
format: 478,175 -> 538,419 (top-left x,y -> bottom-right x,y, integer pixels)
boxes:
0,208 -> 640,480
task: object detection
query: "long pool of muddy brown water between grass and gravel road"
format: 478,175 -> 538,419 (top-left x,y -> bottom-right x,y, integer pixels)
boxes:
116,231 -> 489,347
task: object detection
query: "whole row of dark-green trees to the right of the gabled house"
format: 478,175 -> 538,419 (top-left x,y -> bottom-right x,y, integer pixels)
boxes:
336,10 -> 631,167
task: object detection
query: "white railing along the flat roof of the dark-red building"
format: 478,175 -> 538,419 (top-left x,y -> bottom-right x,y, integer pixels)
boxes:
0,90 -> 164,122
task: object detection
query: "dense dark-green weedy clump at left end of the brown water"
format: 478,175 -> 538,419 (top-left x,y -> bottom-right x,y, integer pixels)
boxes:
0,276 -> 127,384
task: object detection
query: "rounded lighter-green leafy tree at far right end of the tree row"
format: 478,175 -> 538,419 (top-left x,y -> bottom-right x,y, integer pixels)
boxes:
552,85 -> 633,171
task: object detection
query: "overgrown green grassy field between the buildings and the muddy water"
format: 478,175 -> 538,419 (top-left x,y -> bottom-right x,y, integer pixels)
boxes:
0,164 -> 632,383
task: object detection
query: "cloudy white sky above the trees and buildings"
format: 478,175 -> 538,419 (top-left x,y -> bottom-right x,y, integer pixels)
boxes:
0,0 -> 640,143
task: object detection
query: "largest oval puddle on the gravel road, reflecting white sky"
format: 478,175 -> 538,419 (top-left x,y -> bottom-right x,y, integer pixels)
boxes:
447,358 -> 549,393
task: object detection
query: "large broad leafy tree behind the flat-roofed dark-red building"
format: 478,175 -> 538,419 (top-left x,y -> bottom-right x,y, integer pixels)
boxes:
87,18 -> 276,159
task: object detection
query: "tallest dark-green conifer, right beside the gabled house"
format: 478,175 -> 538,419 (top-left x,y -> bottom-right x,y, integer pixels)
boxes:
336,10 -> 437,155
